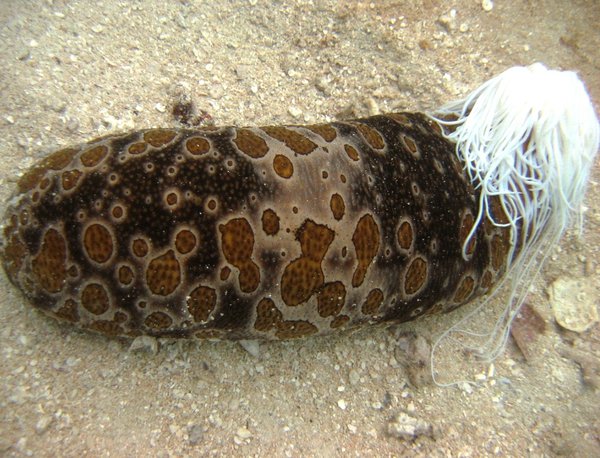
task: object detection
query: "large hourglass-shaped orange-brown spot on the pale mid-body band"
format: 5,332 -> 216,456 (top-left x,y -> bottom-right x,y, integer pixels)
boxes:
281,220 -> 335,306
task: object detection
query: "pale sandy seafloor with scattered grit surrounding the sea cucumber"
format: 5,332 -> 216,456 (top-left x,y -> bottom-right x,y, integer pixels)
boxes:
0,0 -> 600,457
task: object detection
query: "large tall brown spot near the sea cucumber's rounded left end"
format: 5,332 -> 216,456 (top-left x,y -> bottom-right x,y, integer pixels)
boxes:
31,229 -> 67,293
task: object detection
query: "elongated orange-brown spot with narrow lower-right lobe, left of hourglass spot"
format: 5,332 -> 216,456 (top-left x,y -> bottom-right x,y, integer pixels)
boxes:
219,218 -> 260,293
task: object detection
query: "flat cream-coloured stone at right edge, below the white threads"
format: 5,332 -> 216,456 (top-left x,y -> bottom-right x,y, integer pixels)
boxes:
548,278 -> 599,332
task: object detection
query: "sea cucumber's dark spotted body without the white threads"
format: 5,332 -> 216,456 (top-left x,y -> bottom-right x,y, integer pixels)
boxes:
1,113 -> 509,339
